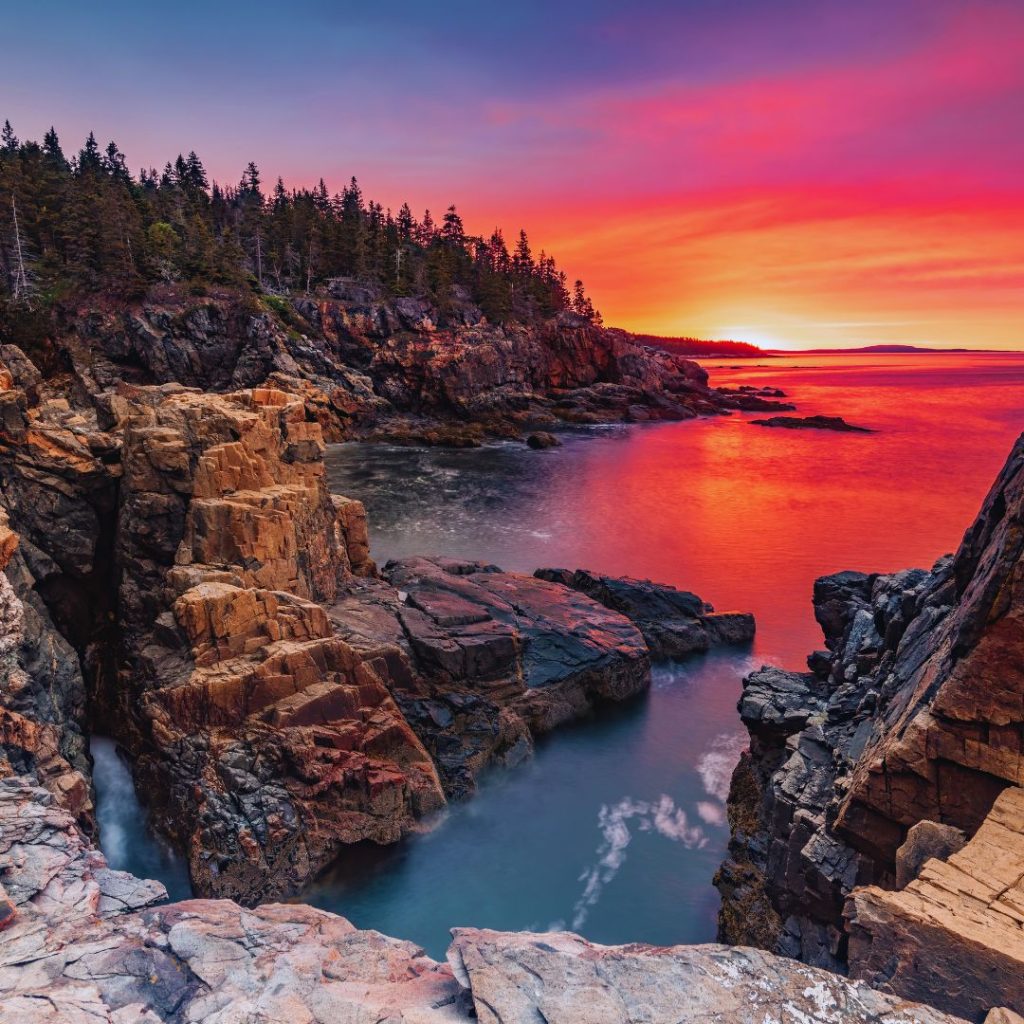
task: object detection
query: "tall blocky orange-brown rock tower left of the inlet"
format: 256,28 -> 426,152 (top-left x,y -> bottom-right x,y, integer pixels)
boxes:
114,387 -> 444,902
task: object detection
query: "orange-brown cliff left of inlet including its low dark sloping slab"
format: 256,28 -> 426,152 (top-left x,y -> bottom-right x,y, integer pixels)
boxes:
0,352 -> 742,903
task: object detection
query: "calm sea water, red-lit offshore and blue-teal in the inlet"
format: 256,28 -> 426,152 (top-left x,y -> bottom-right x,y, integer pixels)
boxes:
94,354 -> 1024,955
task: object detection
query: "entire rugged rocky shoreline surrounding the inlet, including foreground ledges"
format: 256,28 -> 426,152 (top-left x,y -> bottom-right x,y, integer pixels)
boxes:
0,292 -> 1024,1024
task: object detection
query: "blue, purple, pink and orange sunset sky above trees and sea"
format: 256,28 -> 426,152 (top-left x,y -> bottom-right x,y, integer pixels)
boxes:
0,0 -> 1024,348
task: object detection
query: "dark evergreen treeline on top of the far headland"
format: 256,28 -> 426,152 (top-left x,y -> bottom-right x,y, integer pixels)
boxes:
0,122 -> 600,323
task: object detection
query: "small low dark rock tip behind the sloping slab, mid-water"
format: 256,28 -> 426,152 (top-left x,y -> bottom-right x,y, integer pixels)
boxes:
534,569 -> 755,658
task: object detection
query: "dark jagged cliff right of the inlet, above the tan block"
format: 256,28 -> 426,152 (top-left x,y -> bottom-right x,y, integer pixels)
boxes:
718,438 -> 1024,967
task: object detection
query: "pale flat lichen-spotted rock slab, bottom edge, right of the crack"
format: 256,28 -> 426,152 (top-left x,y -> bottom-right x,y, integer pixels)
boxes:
449,928 -> 955,1024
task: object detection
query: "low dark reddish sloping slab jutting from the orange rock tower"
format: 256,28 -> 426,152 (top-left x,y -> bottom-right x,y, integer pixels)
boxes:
331,558 -> 650,798
